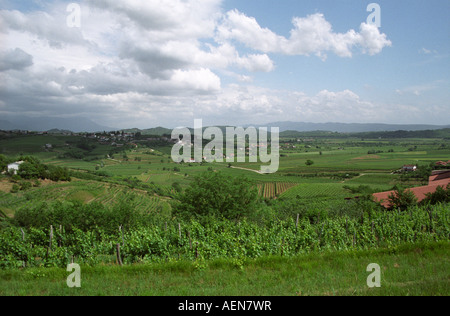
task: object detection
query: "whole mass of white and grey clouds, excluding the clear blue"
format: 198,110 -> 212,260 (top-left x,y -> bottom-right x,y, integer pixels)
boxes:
0,0 -> 422,128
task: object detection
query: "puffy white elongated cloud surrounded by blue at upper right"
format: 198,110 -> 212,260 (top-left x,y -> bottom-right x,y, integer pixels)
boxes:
217,10 -> 392,57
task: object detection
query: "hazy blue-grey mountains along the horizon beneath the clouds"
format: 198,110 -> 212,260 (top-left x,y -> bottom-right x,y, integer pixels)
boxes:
0,117 -> 450,136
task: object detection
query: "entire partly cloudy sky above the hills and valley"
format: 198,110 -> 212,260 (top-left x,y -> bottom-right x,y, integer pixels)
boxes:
0,0 -> 450,129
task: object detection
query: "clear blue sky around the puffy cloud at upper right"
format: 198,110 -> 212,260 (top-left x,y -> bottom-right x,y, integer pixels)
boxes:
226,0 -> 450,93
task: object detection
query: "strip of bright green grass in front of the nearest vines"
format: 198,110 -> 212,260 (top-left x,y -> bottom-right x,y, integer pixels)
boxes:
0,242 -> 450,296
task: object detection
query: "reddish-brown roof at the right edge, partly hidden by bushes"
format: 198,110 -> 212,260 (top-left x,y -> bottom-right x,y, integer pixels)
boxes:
373,170 -> 450,208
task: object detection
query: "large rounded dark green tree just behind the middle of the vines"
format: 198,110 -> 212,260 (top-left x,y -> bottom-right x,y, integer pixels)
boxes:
174,172 -> 259,220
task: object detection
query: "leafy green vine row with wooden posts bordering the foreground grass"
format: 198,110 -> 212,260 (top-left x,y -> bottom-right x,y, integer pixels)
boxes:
0,204 -> 450,268
